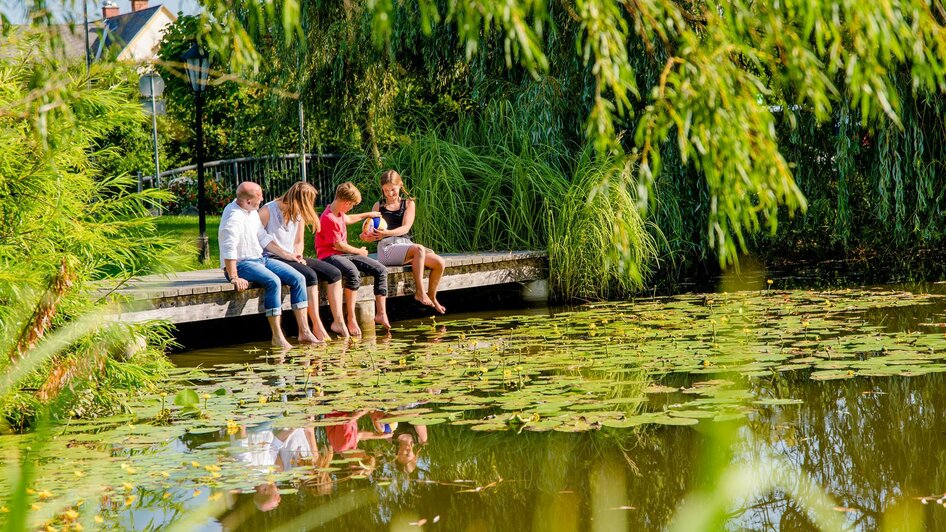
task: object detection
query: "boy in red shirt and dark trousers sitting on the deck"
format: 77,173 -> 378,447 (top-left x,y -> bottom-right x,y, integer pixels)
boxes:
315,182 -> 391,336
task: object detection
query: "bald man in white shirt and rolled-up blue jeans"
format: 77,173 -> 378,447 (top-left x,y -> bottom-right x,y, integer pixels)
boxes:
217,181 -> 319,347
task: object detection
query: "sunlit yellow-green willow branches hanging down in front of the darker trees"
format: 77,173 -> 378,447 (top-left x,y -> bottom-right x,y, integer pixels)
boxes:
186,0 -> 946,263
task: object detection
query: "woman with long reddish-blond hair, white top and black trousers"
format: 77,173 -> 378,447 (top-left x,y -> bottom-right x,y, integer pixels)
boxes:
259,181 -> 348,341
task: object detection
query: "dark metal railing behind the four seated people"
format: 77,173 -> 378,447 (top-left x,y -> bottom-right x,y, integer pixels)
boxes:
138,153 -> 342,206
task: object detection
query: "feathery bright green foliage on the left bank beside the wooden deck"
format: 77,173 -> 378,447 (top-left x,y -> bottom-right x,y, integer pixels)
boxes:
0,31 -> 176,428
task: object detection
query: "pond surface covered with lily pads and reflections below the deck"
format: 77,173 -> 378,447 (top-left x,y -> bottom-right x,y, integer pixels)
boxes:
0,281 -> 946,530
